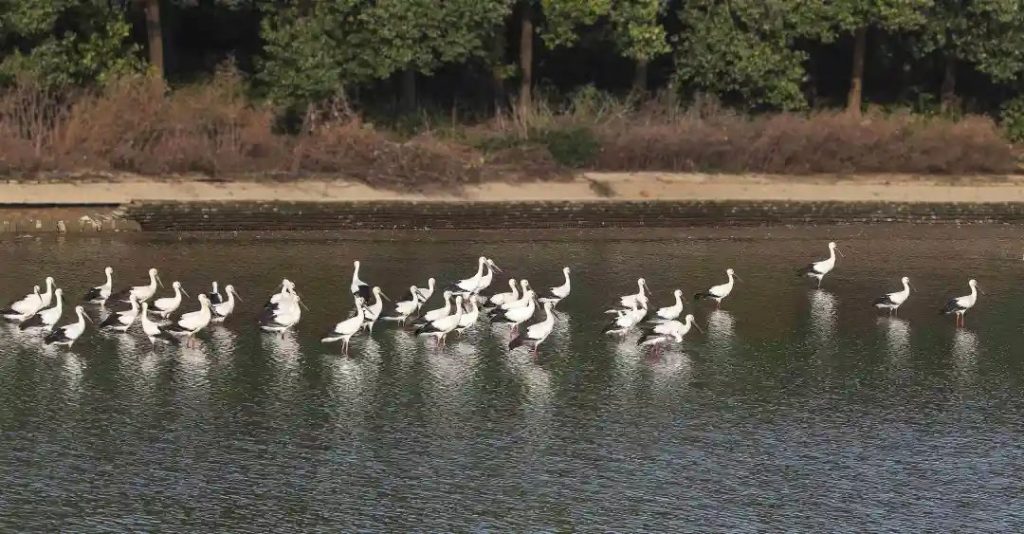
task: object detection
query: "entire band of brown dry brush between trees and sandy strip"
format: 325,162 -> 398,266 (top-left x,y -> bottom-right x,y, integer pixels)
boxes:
0,73 -> 1018,190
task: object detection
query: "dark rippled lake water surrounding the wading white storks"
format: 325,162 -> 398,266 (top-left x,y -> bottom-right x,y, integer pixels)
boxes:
0,225 -> 1024,532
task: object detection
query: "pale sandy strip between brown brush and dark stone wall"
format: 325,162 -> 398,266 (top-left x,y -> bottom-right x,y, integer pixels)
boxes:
0,172 -> 1024,207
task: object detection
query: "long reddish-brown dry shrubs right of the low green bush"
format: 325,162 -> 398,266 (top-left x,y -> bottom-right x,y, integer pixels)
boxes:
593,108 -> 1015,174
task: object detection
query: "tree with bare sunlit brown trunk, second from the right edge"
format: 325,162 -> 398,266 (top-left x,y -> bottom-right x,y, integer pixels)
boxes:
824,0 -> 933,115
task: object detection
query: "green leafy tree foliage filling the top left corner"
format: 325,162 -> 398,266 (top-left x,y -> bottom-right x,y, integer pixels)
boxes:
0,0 -> 139,87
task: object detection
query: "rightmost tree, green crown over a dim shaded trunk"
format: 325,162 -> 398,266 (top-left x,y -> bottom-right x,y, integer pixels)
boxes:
918,0 -> 1024,113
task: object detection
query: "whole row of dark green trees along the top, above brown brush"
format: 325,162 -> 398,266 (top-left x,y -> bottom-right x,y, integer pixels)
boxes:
0,0 -> 1024,128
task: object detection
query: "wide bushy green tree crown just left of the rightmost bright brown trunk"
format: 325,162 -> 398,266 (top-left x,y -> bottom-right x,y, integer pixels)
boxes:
675,0 -> 827,110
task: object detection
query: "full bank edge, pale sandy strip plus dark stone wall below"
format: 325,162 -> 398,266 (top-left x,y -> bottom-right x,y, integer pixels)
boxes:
6,172 -> 1024,234
